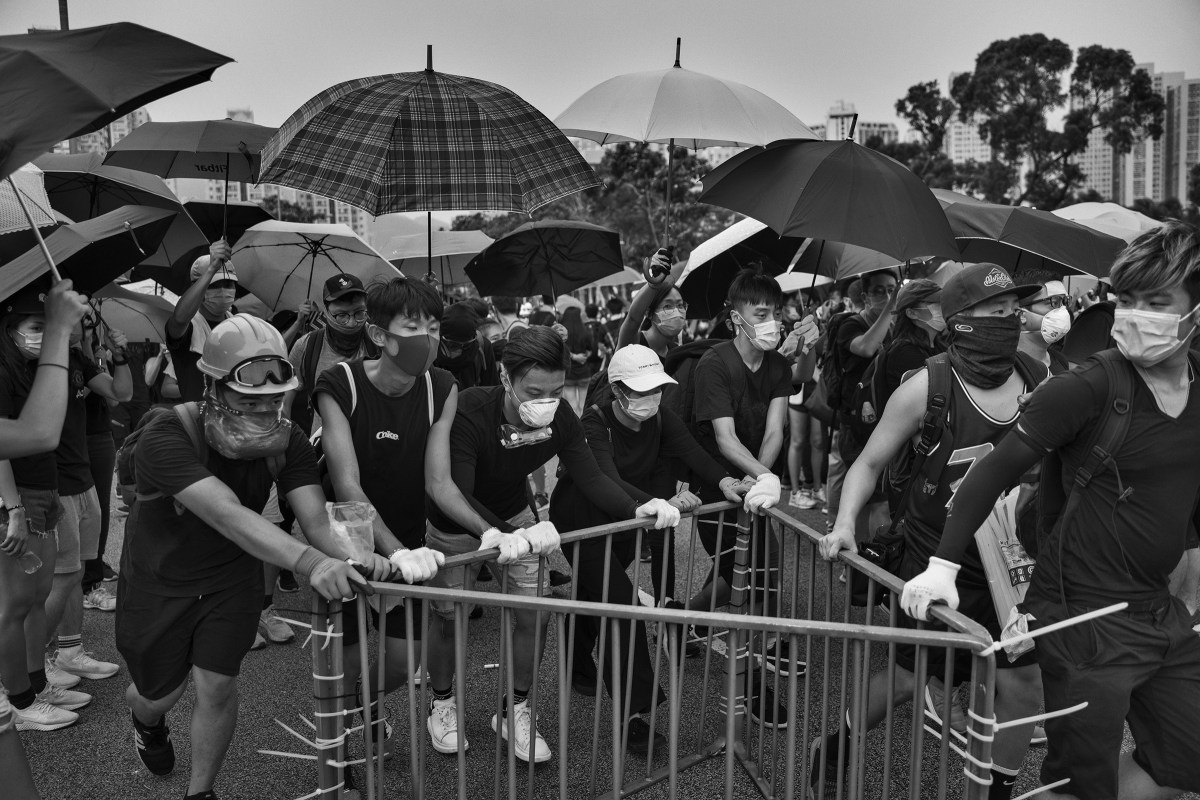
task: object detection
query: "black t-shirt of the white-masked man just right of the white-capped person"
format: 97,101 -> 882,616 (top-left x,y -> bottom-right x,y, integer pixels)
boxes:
692,342 -> 792,475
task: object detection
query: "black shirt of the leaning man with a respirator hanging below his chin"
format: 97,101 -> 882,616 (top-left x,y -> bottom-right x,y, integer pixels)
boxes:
427,386 -> 638,535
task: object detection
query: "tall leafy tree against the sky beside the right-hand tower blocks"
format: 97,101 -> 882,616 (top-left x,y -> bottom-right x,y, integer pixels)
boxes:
945,34 -> 1165,209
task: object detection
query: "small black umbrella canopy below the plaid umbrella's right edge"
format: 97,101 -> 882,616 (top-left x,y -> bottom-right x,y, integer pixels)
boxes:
466,219 -> 624,297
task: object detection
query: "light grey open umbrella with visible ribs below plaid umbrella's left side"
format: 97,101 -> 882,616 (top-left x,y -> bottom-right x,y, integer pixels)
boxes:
230,219 -> 400,312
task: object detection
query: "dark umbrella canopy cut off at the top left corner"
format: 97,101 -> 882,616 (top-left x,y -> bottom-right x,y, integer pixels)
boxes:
0,23 -> 233,178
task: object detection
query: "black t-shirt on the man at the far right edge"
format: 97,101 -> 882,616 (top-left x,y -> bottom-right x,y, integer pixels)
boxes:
1016,360 -> 1200,604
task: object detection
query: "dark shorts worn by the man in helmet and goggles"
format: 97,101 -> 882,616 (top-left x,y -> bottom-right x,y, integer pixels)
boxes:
116,570 -> 263,700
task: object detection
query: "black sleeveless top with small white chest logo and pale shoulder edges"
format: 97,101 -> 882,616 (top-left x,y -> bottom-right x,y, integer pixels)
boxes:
313,361 -> 454,549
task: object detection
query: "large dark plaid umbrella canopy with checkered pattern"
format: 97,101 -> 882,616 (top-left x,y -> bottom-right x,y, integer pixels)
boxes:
259,59 -> 599,216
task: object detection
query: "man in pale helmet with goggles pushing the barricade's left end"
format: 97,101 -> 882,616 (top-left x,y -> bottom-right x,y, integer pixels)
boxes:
116,314 -> 374,799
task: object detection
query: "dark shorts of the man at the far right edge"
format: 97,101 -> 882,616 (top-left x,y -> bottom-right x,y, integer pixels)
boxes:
1030,599 -> 1200,800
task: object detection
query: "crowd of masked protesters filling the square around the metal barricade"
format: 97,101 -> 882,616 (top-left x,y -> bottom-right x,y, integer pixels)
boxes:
0,222 -> 1200,800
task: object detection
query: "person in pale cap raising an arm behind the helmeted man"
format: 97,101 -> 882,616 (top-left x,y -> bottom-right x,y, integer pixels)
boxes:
166,239 -> 238,403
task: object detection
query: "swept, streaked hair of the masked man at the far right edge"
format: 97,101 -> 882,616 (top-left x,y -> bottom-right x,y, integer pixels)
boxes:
1109,219 -> 1200,306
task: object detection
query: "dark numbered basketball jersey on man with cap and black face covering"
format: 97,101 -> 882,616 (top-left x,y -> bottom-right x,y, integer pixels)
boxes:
901,367 -> 1031,582
